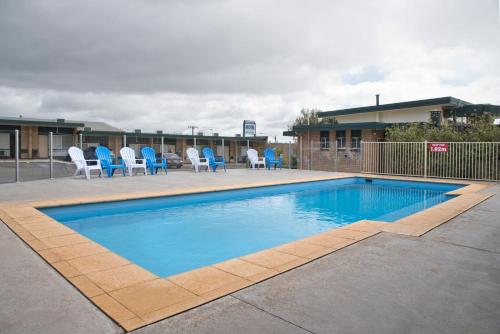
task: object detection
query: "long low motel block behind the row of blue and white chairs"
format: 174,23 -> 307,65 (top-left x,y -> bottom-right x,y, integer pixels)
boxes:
0,116 -> 267,163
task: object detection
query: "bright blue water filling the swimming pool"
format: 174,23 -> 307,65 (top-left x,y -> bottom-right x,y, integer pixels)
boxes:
42,178 -> 461,277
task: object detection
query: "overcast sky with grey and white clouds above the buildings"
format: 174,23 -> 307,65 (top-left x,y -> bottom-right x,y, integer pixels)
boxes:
0,0 -> 500,137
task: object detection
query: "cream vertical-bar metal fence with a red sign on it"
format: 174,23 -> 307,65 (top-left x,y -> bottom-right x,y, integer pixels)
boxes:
361,142 -> 500,181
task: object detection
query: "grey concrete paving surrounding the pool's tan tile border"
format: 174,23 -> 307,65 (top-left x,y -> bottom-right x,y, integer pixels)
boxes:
0,171 -> 500,334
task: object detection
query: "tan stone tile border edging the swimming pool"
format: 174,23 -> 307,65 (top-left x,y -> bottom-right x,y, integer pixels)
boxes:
0,173 -> 492,331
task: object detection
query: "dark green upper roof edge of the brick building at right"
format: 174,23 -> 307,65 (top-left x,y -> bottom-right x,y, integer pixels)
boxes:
318,96 -> 470,117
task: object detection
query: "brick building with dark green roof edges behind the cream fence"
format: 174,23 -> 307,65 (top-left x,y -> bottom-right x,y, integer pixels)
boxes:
283,95 -> 500,172
